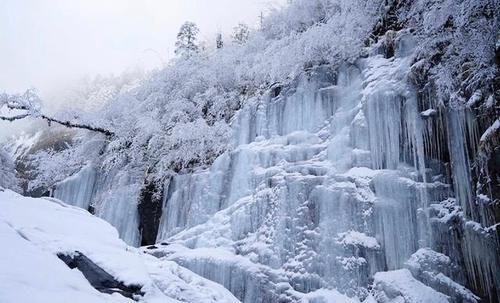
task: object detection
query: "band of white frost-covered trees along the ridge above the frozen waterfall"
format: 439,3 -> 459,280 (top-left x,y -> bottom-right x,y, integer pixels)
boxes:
9,0 -> 386,192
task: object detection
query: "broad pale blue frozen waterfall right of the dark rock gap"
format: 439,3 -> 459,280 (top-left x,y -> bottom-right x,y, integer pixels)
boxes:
150,31 -> 494,302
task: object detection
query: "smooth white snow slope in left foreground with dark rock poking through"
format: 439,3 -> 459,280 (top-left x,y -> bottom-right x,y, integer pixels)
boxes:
0,190 -> 238,303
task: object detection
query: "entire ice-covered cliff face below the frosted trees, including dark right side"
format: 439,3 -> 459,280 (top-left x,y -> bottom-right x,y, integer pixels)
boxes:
9,0 -> 500,302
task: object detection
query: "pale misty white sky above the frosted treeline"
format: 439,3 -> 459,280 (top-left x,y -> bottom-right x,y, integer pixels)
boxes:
0,0 -> 285,95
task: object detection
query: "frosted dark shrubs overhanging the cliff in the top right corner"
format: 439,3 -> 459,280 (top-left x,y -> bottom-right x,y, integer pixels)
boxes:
400,0 -> 500,108
